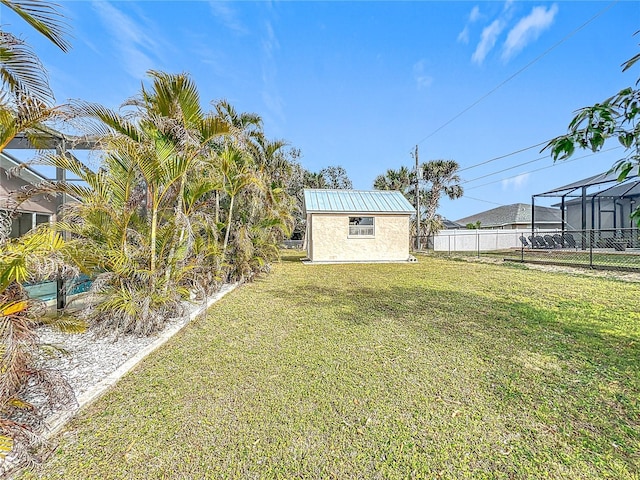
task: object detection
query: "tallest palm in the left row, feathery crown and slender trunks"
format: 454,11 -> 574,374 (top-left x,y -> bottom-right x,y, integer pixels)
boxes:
80,71 -> 229,272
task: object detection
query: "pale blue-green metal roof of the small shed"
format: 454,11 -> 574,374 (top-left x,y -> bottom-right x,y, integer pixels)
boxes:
304,189 -> 415,214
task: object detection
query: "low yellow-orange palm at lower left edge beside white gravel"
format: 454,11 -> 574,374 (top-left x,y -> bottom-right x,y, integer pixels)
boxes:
0,228 -> 83,461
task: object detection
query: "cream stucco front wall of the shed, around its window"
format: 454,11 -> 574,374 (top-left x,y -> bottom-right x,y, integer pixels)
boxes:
307,213 -> 409,262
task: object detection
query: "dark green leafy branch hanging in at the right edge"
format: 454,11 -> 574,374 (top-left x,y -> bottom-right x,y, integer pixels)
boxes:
543,37 -> 640,225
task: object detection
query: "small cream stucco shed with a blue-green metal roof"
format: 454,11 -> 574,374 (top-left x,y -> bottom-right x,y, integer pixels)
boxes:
304,189 -> 415,263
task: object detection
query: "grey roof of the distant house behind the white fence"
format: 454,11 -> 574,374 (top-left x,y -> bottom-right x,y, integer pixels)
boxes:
456,203 -> 562,228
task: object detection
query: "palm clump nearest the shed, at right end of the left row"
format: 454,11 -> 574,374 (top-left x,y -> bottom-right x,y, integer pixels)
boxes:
214,100 -> 297,279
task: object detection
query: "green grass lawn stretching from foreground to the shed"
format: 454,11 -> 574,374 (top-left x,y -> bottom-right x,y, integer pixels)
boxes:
20,253 -> 640,480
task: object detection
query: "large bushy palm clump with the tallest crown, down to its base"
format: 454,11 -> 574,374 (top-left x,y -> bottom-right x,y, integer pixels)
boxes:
21,71 -> 228,334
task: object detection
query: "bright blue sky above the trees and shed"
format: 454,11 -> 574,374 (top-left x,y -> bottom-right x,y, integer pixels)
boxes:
0,0 -> 640,220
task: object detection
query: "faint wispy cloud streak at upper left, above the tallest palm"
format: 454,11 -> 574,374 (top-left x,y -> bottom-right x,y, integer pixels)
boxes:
93,1 -> 161,79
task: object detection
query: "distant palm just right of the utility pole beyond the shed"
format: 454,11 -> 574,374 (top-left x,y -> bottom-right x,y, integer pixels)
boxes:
422,160 -> 463,236
